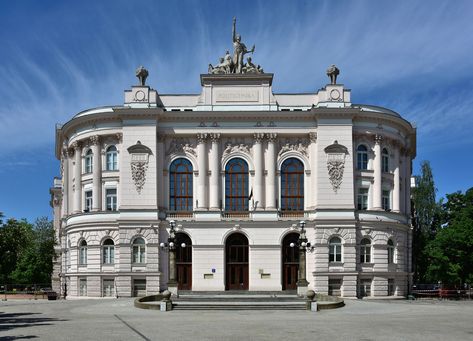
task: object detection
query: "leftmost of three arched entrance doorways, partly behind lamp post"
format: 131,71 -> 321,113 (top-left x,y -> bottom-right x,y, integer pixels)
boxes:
176,233 -> 192,290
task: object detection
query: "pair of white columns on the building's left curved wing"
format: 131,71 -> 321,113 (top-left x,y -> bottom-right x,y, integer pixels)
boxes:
70,135 -> 102,213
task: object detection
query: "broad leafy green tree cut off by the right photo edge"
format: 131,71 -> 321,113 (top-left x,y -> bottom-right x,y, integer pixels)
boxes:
426,188 -> 473,285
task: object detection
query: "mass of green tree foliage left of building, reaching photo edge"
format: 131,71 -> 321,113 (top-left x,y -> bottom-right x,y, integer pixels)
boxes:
0,217 -> 55,284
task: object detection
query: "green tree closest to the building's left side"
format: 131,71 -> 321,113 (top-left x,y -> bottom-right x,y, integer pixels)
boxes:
11,217 -> 55,284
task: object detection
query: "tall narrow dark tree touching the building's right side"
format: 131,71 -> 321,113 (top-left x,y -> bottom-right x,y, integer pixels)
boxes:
412,161 -> 440,283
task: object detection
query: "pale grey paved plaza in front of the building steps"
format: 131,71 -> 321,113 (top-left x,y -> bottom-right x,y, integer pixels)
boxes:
0,299 -> 473,341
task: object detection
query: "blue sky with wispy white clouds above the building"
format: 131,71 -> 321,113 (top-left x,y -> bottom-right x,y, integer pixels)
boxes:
0,0 -> 473,220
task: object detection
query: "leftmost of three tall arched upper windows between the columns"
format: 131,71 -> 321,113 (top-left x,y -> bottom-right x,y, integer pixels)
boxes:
169,158 -> 193,211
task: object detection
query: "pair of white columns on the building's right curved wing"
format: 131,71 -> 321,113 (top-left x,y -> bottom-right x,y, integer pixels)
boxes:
373,135 -> 401,212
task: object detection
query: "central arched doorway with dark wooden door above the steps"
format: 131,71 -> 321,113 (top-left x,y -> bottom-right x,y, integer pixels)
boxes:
225,233 -> 248,290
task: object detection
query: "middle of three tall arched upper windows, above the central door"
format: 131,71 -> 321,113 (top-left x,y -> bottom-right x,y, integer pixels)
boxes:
225,158 -> 249,211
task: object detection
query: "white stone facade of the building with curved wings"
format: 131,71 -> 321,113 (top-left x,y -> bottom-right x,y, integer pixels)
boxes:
51,74 -> 416,297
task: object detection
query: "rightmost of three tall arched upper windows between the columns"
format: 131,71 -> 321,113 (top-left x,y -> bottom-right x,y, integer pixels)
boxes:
281,158 -> 304,211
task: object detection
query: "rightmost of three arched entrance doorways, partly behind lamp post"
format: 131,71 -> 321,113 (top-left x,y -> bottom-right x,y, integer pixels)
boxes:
282,233 -> 299,290
